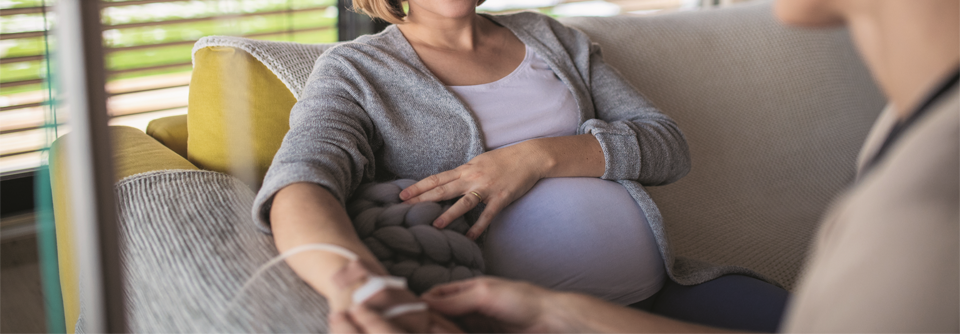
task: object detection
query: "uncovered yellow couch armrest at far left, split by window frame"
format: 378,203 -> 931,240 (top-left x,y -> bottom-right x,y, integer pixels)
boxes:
50,126 -> 199,333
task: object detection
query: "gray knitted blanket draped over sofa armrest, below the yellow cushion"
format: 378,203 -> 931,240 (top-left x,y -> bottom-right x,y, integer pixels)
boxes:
76,170 -> 327,333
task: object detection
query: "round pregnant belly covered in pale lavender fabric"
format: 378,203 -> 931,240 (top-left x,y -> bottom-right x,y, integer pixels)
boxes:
483,178 -> 664,304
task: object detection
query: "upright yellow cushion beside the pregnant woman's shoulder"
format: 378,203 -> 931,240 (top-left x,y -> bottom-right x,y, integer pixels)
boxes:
187,46 -> 297,189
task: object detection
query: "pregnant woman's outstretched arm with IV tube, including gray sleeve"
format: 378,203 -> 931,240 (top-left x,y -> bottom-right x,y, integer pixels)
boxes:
253,50 -> 386,310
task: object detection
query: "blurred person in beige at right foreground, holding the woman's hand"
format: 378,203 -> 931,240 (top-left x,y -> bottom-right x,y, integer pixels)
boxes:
330,0 -> 960,332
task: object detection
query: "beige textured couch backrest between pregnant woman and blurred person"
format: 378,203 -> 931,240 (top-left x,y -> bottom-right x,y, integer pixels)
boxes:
564,3 -> 885,288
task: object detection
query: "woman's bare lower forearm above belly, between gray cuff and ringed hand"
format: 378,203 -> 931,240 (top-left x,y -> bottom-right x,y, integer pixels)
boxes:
526,134 -> 606,178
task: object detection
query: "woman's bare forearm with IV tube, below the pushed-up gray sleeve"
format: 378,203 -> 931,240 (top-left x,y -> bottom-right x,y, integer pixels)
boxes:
270,183 -> 386,311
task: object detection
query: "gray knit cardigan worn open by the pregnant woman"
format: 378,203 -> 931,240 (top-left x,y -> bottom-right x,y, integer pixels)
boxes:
253,12 -> 690,268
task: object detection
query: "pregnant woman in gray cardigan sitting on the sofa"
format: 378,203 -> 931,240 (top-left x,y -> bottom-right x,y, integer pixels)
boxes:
253,0 -> 690,324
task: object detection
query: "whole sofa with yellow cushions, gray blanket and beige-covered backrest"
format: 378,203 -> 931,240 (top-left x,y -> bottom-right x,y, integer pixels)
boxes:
51,2 -> 885,332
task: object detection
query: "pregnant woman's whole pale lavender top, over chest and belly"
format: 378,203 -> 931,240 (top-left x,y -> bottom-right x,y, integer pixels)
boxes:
449,48 -> 665,305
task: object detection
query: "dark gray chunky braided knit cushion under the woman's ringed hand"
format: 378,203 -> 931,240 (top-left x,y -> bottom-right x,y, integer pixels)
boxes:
347,180 -> 483,293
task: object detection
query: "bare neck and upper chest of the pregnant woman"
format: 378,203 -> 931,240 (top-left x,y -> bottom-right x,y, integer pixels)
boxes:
397,2 -> 492,51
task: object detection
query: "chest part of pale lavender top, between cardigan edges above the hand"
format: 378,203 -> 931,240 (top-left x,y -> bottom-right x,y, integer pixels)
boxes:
448,48 -> 580,150
